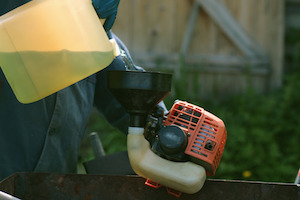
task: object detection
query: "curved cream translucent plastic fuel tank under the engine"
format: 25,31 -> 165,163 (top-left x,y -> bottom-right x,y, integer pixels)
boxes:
127,127 -> 206,194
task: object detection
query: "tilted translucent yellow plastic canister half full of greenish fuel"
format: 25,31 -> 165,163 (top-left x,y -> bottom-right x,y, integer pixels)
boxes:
0,0 -> 118,103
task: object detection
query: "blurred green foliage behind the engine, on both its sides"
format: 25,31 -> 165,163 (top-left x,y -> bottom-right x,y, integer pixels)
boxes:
80,27 -> 300,182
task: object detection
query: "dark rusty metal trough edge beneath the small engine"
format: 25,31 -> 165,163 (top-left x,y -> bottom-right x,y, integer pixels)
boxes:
0,173 -> 300,200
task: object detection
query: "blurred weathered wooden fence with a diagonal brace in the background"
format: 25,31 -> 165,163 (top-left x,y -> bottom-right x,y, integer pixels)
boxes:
113,0 -> 284,98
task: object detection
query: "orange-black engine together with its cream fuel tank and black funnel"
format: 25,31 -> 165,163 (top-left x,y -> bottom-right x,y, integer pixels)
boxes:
108,71 -> 227,196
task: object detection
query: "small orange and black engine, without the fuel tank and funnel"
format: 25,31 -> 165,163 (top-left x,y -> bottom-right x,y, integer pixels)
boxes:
145,100 -> 227,176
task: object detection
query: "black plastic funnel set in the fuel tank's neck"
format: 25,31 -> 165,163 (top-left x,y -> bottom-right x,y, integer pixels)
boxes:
108,71 -> 172,127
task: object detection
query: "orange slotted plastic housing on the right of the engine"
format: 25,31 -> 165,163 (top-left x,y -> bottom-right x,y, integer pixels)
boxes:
164,101 -> 227,176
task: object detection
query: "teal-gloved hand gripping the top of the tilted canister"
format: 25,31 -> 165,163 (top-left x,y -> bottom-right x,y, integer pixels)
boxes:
92,0 -> 120,32
